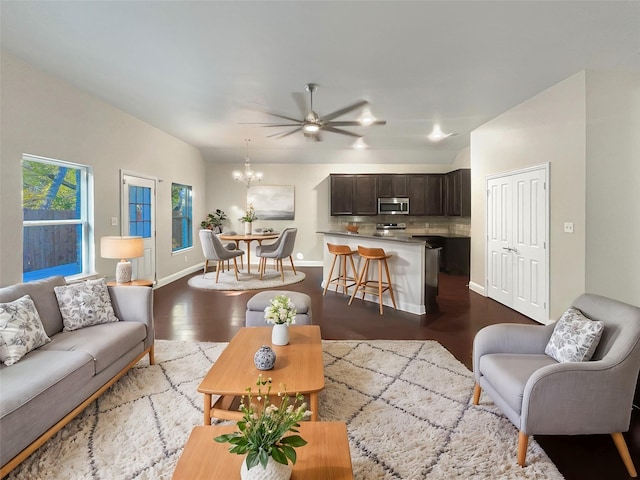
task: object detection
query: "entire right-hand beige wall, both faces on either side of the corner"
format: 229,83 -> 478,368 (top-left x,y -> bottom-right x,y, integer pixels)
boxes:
471,71 -> 640,320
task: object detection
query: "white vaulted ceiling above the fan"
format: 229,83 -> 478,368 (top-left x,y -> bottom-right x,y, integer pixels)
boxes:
0,0 -> 640,164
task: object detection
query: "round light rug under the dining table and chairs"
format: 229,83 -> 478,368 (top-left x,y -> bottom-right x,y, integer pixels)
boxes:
187,265 -> 305,290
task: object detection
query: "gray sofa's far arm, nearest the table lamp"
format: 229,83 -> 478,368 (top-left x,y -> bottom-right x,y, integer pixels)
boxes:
108,285 -> 155,348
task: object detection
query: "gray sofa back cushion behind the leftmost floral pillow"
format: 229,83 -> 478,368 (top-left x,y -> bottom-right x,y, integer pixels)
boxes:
0,276 -> 65,337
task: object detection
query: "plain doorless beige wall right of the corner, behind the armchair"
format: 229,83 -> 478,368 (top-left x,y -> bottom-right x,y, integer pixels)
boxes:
586,71 -> 640,305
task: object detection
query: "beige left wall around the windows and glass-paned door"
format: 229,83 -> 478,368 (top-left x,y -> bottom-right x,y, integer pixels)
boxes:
0,52 -> 205,285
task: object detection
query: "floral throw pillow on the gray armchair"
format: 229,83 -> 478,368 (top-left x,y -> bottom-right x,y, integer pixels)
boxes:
544,307 -> 604,362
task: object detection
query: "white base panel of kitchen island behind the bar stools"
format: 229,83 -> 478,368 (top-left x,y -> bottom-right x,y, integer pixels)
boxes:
318,232 -> 426,315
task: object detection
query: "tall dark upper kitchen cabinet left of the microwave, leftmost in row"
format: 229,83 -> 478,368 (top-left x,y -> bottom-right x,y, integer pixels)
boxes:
331,174 -> 378,215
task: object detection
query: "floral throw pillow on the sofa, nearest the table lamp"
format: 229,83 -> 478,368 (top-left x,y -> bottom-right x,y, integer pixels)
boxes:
53,278 -> 118,332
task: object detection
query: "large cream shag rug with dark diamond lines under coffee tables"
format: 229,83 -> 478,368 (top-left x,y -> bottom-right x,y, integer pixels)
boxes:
7,340 -> 562,480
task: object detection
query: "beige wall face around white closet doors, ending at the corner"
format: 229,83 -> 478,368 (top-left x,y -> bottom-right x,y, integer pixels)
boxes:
471,72 -> 586,318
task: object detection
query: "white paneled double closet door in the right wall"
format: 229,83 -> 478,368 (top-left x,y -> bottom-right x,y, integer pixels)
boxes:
487,166 -> 549,323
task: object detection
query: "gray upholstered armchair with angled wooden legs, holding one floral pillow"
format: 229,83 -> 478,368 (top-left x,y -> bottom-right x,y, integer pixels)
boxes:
473,294 -> 640,477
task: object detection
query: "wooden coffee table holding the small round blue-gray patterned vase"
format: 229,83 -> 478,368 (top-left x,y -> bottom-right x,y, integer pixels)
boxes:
198,325 -> 324,425
